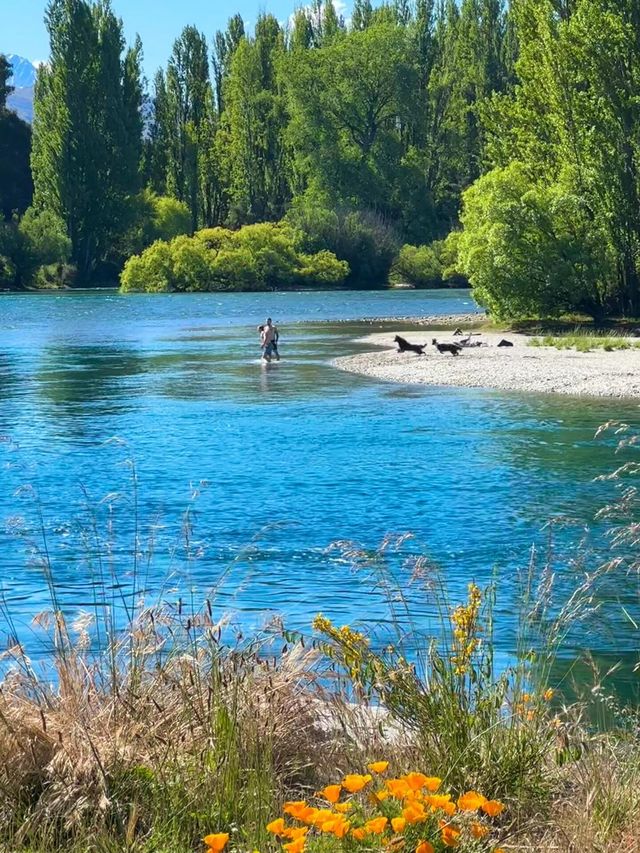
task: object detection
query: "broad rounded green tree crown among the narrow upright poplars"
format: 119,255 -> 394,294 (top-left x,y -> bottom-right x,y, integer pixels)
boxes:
287,24 -> 415,218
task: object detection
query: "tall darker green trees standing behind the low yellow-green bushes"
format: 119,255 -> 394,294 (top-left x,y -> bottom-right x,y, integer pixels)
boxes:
0,0 -> 514,284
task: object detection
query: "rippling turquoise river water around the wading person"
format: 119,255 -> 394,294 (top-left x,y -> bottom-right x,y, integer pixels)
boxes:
0,291 -> 640,672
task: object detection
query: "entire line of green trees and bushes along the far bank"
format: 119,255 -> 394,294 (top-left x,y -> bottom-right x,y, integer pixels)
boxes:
0,0 -> 640,318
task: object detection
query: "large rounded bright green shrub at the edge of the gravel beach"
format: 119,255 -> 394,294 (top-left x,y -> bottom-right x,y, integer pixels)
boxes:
459,162 -> 615,319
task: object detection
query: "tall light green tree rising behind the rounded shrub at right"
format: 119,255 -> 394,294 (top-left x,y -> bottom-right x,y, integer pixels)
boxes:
482,0 -> 640,316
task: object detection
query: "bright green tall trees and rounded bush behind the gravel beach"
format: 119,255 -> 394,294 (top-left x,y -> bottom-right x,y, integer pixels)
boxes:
460,0 -> 640,319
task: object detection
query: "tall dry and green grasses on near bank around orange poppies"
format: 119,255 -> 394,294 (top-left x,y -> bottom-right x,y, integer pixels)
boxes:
0,424 -> 640,853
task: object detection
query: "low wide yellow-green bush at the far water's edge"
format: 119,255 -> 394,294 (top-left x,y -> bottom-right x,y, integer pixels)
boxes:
121,222 -> 349,291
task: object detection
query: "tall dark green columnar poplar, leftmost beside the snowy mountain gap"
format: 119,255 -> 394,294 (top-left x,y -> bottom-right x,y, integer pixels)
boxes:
31,0 -> 142,281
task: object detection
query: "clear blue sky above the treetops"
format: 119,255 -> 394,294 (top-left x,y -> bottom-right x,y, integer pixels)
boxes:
0,0 -> 350,77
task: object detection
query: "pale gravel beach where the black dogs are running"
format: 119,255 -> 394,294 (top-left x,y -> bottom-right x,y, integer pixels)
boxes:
334,317 -> 640,398
